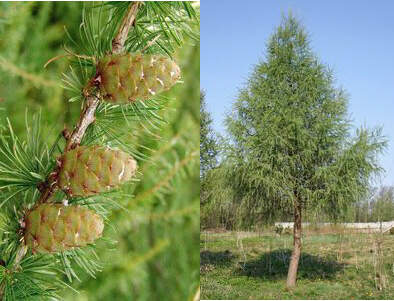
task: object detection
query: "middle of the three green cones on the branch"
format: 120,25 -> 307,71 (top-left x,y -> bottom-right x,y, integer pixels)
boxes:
58,146 -> 137,197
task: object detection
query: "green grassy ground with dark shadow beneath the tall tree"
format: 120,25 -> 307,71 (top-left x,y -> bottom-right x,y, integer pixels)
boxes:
200,231 -> 394,300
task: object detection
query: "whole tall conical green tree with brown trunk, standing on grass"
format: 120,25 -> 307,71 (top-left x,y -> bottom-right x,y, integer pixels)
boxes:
227,15 -> 385,288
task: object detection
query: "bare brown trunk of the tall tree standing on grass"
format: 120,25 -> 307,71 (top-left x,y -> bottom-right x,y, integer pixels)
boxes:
286,197 -> 301,289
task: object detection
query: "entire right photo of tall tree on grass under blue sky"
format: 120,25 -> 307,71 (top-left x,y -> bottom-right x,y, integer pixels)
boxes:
200,0 -> 394,300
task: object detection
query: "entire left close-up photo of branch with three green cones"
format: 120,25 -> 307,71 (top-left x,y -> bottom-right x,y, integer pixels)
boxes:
0,1 -> 200,301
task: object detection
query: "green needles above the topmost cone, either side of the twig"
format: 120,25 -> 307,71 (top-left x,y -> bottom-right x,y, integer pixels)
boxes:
72,1 -> 199,59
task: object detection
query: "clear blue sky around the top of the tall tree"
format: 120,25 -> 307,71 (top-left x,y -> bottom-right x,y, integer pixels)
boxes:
200,0 -> 394,185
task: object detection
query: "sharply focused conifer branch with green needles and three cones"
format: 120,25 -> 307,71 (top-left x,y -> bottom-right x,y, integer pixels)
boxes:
0,2 -> 198,300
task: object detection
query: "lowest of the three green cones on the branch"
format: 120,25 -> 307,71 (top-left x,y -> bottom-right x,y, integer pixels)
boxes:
24,203 -> 104,253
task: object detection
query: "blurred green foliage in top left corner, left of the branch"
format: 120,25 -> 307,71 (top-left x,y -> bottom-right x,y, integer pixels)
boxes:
0,2 -> 82,132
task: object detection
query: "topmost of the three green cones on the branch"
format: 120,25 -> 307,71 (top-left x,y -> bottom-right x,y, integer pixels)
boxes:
96,53 -> 180,104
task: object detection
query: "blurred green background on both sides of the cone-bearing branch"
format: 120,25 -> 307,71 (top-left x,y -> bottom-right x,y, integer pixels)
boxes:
0,2 -> 200,300
